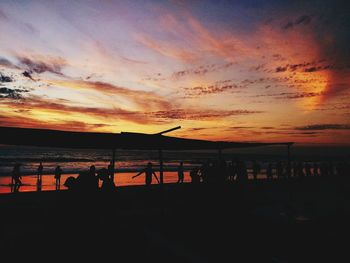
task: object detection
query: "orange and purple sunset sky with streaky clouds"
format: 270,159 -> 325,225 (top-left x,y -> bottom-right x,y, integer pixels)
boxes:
0,0 -> 350,145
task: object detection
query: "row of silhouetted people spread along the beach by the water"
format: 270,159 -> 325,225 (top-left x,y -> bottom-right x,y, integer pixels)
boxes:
11,159 -> 350,192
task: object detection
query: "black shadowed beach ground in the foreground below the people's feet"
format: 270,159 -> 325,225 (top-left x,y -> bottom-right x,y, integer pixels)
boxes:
0,178 -> 350,262
